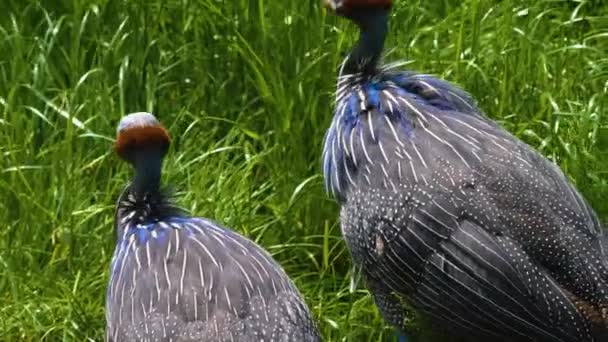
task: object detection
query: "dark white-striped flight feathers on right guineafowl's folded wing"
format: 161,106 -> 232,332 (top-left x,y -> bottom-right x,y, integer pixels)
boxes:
414,214 -> 585,341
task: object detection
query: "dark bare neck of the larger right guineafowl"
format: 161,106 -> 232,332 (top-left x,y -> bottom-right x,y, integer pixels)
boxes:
343,9 -> 389,74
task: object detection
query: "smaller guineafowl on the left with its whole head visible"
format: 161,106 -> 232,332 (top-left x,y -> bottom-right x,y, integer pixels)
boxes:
105,112 -> 321,342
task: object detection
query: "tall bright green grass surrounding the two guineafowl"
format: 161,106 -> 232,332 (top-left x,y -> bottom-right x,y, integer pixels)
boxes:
0,0 -> 608,341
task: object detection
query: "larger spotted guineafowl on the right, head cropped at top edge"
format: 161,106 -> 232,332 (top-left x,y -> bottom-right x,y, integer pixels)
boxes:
322,0 -> 608,342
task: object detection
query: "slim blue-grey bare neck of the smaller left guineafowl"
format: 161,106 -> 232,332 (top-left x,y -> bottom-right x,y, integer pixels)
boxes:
131,151 -> 163,196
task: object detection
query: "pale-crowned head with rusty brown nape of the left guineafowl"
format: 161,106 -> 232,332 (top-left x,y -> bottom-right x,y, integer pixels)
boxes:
114,112 -> 169,164
